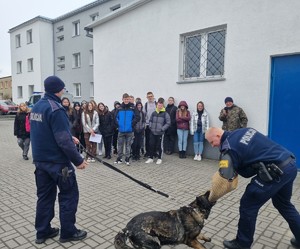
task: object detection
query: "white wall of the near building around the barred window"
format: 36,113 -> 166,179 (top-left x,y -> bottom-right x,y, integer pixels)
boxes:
93,0 -> 300,133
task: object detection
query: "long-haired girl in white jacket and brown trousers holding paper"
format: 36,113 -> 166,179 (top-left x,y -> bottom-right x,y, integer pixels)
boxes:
81,102 -> 99,163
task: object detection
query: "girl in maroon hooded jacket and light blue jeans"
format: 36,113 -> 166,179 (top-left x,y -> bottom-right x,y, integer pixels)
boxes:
176,100 -> 191,158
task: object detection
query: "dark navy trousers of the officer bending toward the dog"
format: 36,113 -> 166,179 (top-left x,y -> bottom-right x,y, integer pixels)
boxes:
237,162 -> 300,247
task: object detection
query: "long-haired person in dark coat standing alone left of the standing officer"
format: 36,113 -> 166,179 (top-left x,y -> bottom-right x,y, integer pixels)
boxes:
14,103 -> 30,160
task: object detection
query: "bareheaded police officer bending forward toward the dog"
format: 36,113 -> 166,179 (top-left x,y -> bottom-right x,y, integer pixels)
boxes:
205,127 -> 300,249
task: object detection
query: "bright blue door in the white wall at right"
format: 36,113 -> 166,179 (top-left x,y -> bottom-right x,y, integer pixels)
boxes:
269,55 -> 300,167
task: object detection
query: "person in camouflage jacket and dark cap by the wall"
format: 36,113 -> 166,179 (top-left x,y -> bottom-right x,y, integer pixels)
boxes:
219,97 -> 248,131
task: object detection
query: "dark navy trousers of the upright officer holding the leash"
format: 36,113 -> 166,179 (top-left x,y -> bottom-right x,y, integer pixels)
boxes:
35,162 -> 79,239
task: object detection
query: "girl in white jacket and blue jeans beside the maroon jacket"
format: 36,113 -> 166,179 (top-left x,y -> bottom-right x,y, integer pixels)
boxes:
190,101 -> 209,161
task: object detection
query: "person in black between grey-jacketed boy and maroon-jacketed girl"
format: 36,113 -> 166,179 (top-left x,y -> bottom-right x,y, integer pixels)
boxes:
164,97 -> 177,155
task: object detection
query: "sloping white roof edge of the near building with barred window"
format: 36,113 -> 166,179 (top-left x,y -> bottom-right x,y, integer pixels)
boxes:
86,0 -> 153,29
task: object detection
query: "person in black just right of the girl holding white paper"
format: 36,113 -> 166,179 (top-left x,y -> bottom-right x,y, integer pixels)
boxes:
98,103 -> 114,159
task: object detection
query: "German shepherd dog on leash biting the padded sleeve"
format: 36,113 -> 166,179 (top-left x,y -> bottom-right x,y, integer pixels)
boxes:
114,191 -> 215,249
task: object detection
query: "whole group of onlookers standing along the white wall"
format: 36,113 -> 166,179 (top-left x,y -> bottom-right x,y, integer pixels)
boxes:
14,89 -> 248,165
